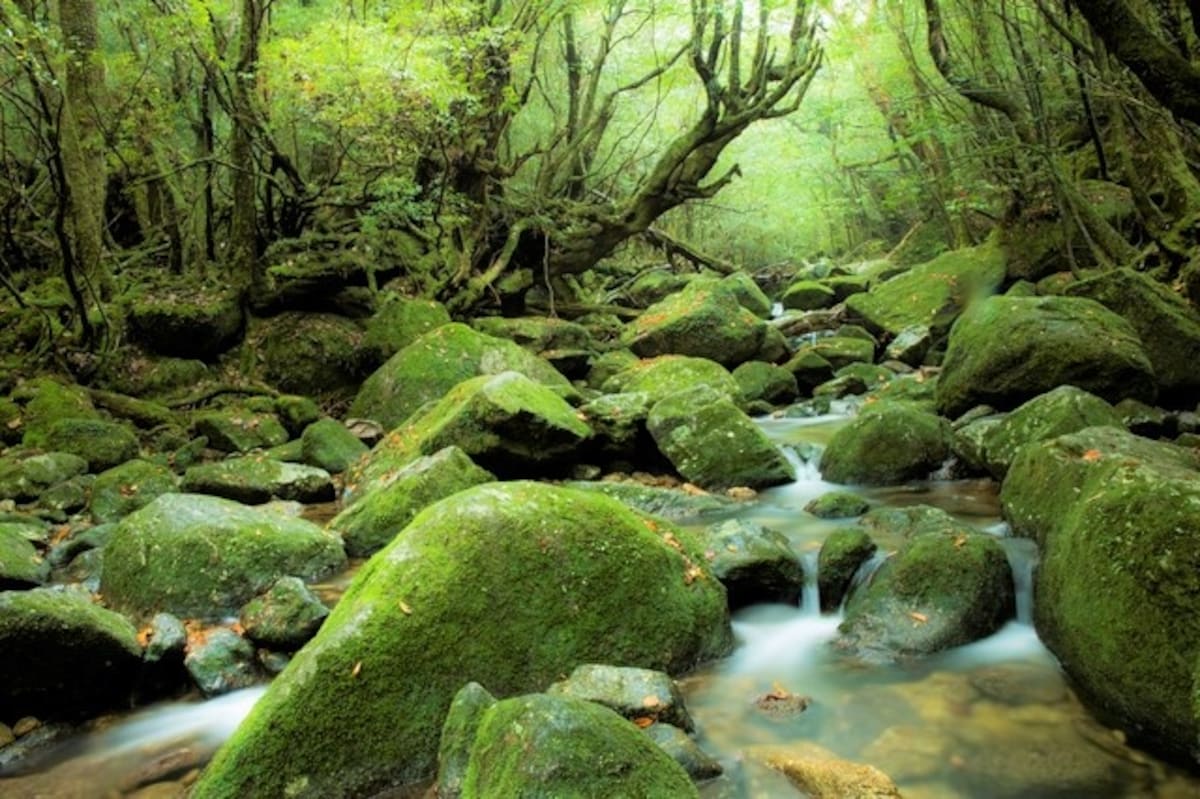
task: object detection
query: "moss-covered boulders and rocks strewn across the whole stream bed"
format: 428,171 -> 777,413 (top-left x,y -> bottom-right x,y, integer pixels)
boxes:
0,242 -> 1200,797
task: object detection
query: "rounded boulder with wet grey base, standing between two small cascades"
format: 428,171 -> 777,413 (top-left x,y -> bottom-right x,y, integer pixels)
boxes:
838,531 -> 1015,661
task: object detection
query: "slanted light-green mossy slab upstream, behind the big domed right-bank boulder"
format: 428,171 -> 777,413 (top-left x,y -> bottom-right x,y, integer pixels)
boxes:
846,241 -> 1006,336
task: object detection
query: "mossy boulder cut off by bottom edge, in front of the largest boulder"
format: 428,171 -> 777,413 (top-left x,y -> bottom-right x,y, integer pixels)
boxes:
438,693 -> 700,799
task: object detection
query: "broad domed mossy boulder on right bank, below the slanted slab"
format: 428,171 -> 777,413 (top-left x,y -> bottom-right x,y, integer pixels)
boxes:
937,296 -> 1156,416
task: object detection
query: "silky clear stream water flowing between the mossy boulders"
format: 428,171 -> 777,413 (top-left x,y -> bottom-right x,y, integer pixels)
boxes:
7,407 -> 1200,799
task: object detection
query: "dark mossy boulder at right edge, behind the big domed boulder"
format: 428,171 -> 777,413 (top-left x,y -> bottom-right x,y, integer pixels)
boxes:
1066,269 -> 1200,408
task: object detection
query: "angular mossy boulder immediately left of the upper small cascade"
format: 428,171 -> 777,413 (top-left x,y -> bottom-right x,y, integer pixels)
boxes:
646,386 -> 796,488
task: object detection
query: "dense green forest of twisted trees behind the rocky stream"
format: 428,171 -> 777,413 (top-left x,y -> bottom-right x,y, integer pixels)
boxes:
0,0 -> 1200,364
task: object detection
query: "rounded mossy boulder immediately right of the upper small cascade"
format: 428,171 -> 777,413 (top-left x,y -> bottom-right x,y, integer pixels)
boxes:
821,402 -> 952,486
